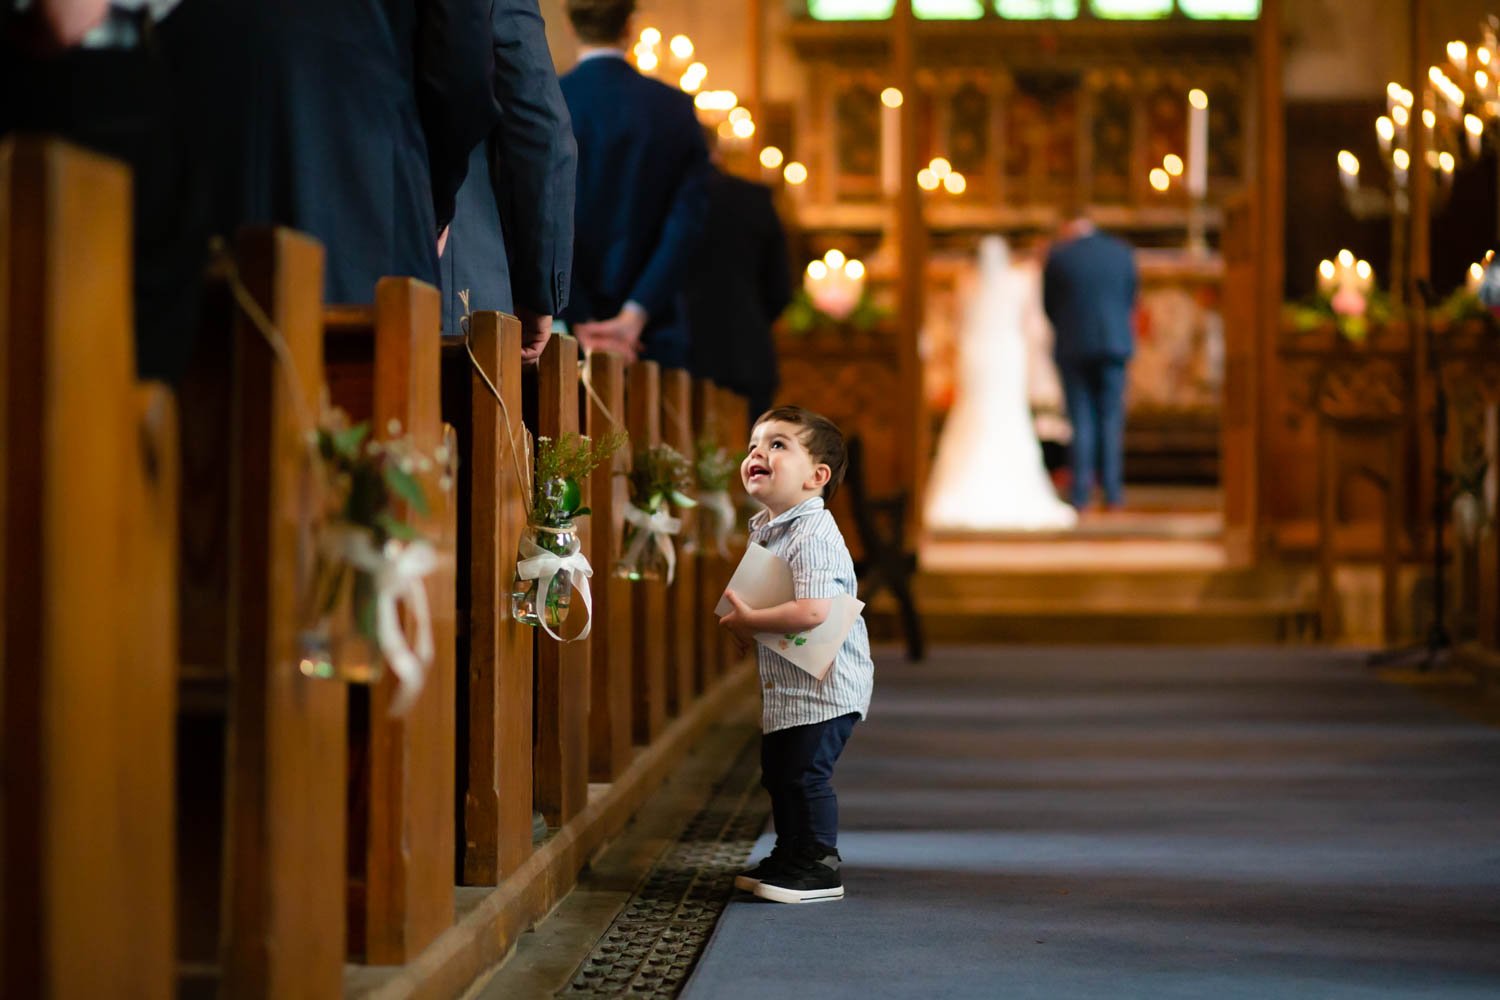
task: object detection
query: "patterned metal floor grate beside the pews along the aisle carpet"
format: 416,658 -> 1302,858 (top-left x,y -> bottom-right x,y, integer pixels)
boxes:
557,739 -> 771,1000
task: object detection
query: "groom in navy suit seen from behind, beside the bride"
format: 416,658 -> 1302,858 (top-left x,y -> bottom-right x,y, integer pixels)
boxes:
1043,213 -> 1140,510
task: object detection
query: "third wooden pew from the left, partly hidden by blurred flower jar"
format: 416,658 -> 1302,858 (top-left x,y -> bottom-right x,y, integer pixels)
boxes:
324,277 -> 458,964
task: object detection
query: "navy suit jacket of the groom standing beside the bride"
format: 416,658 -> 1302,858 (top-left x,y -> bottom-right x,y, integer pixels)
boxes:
1043,229 -> 1139,364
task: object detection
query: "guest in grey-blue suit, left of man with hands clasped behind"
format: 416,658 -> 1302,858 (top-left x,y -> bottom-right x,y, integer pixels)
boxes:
441,0 -> 578,363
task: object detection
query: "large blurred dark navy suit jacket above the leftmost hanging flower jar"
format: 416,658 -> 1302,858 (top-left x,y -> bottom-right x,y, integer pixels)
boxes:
161,0 -> 500,303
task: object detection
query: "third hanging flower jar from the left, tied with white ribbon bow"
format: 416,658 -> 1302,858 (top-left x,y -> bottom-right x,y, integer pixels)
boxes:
615,444 -> 698,583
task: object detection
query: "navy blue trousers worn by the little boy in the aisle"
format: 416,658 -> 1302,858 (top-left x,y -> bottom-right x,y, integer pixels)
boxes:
761,712 -> 860,847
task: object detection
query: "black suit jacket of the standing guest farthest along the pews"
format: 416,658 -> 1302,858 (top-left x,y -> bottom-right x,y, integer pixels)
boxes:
687,169 -> 792,400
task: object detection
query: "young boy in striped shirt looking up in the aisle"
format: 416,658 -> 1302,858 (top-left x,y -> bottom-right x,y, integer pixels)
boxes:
720,406 -> 875,903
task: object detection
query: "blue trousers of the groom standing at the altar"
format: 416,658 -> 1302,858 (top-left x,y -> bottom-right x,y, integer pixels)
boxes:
1058,360 -> 1125,510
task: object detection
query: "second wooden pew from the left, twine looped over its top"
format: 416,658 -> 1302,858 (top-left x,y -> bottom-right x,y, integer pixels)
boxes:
177,229 -> 345,997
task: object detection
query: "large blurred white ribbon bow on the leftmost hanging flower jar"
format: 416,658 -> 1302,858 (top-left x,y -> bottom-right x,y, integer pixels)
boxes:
329,529 -> 443,715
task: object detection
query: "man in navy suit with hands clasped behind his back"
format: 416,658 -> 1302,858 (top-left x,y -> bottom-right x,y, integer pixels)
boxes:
563,0 -> 708,367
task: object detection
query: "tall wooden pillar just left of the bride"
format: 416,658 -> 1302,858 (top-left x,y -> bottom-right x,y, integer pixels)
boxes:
890,0 -> 929,528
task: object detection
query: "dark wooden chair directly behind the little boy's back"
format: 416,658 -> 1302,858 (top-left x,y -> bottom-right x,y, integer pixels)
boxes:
843,435 -> 926,661
